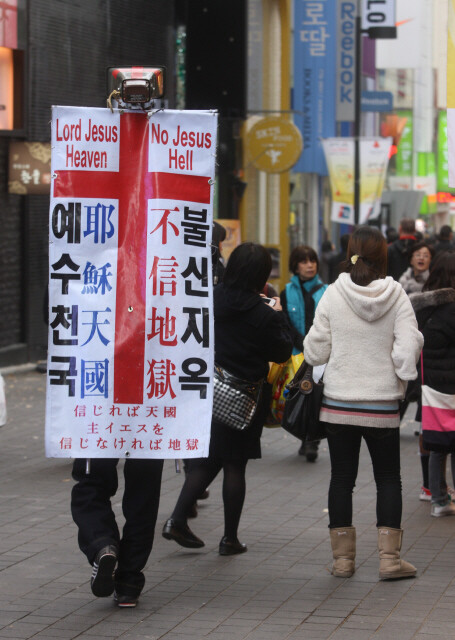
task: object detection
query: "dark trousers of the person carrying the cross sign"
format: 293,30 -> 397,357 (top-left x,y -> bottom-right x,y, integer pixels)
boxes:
71,458 -> 163,596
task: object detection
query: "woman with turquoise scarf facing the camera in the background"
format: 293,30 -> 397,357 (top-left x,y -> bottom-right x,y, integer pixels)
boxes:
280,245 -> 327,462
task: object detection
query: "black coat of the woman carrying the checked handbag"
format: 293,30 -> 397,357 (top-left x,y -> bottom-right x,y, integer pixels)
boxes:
209,284 -> 292,460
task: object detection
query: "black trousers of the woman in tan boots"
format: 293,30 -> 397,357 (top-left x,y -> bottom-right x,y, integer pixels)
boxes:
325,423 -> 402,529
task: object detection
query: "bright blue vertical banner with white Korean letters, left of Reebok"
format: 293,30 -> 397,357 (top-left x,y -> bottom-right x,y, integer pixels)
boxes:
292,0 -> 336,176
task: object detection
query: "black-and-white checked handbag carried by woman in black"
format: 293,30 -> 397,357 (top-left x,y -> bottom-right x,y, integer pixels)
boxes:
212,364 -> 263,431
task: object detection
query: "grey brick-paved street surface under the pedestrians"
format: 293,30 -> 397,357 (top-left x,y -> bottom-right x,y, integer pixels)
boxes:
0,371 -> 455,640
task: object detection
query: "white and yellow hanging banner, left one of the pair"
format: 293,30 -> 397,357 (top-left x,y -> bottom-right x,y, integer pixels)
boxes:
322,138 -> 354,224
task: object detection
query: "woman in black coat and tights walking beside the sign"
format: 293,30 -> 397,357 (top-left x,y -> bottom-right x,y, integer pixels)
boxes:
163,242 -> 292,555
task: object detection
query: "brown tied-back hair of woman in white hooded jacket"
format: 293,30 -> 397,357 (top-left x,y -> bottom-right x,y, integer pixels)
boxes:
341,225 -> 387,287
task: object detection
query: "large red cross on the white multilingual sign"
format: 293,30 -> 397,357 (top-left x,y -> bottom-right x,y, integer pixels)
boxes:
54,113 -> 210,404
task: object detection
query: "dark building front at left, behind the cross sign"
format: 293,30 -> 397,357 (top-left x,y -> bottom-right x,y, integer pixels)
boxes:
0,0 -> 175,367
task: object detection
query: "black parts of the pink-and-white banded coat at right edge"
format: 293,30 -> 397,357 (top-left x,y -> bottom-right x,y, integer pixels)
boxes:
409,289 -> 455,452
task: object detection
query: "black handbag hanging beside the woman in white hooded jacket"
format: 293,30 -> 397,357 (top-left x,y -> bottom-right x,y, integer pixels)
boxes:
281,361 -> 326,442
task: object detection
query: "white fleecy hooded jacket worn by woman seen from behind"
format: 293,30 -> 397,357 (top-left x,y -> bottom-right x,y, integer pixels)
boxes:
303,273 -> 423,401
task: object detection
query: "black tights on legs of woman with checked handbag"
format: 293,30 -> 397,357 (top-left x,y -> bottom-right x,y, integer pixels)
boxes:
171,458 -> 247,540
